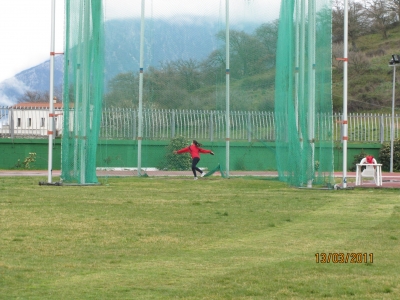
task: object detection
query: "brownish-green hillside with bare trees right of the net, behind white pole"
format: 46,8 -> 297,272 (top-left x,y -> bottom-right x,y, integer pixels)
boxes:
332,0 -> 400,112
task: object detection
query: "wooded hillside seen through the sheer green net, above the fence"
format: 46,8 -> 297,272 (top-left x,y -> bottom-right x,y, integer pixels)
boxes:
104,21 -> 278,110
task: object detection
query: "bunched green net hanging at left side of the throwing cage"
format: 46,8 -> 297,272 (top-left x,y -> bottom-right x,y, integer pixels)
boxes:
61,0 -> 104,184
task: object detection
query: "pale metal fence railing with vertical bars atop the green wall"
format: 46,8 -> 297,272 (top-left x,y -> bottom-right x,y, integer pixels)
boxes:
0,107 -> 400,143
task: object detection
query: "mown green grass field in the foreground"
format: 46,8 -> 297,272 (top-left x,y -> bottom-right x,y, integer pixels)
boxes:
0,177 -> 400,299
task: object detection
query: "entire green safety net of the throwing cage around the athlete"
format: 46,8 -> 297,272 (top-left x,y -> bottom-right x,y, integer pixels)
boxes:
61,0 -> 333,186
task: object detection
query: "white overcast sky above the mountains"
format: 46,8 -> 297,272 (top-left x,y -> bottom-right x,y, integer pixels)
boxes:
0,0 -> 281,82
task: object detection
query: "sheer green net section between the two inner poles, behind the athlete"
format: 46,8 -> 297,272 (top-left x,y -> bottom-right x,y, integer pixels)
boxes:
138,0 -> 226,175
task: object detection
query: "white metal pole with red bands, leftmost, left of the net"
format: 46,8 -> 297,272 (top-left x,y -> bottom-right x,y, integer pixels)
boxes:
47,0 -> 56,183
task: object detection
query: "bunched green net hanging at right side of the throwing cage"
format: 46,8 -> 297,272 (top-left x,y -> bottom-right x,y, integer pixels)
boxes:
275,0 -> 333,186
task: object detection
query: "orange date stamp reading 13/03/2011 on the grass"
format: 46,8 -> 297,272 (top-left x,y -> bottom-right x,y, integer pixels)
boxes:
315,252 -> 374,264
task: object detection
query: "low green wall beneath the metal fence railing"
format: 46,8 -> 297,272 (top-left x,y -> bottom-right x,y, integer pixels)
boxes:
0,139 -> 382,172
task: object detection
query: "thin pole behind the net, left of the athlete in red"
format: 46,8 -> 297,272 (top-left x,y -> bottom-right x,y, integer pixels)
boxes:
137,0 -> 145,176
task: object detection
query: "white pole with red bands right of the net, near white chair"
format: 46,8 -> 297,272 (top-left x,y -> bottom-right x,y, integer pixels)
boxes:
342,0 -> 349,188
